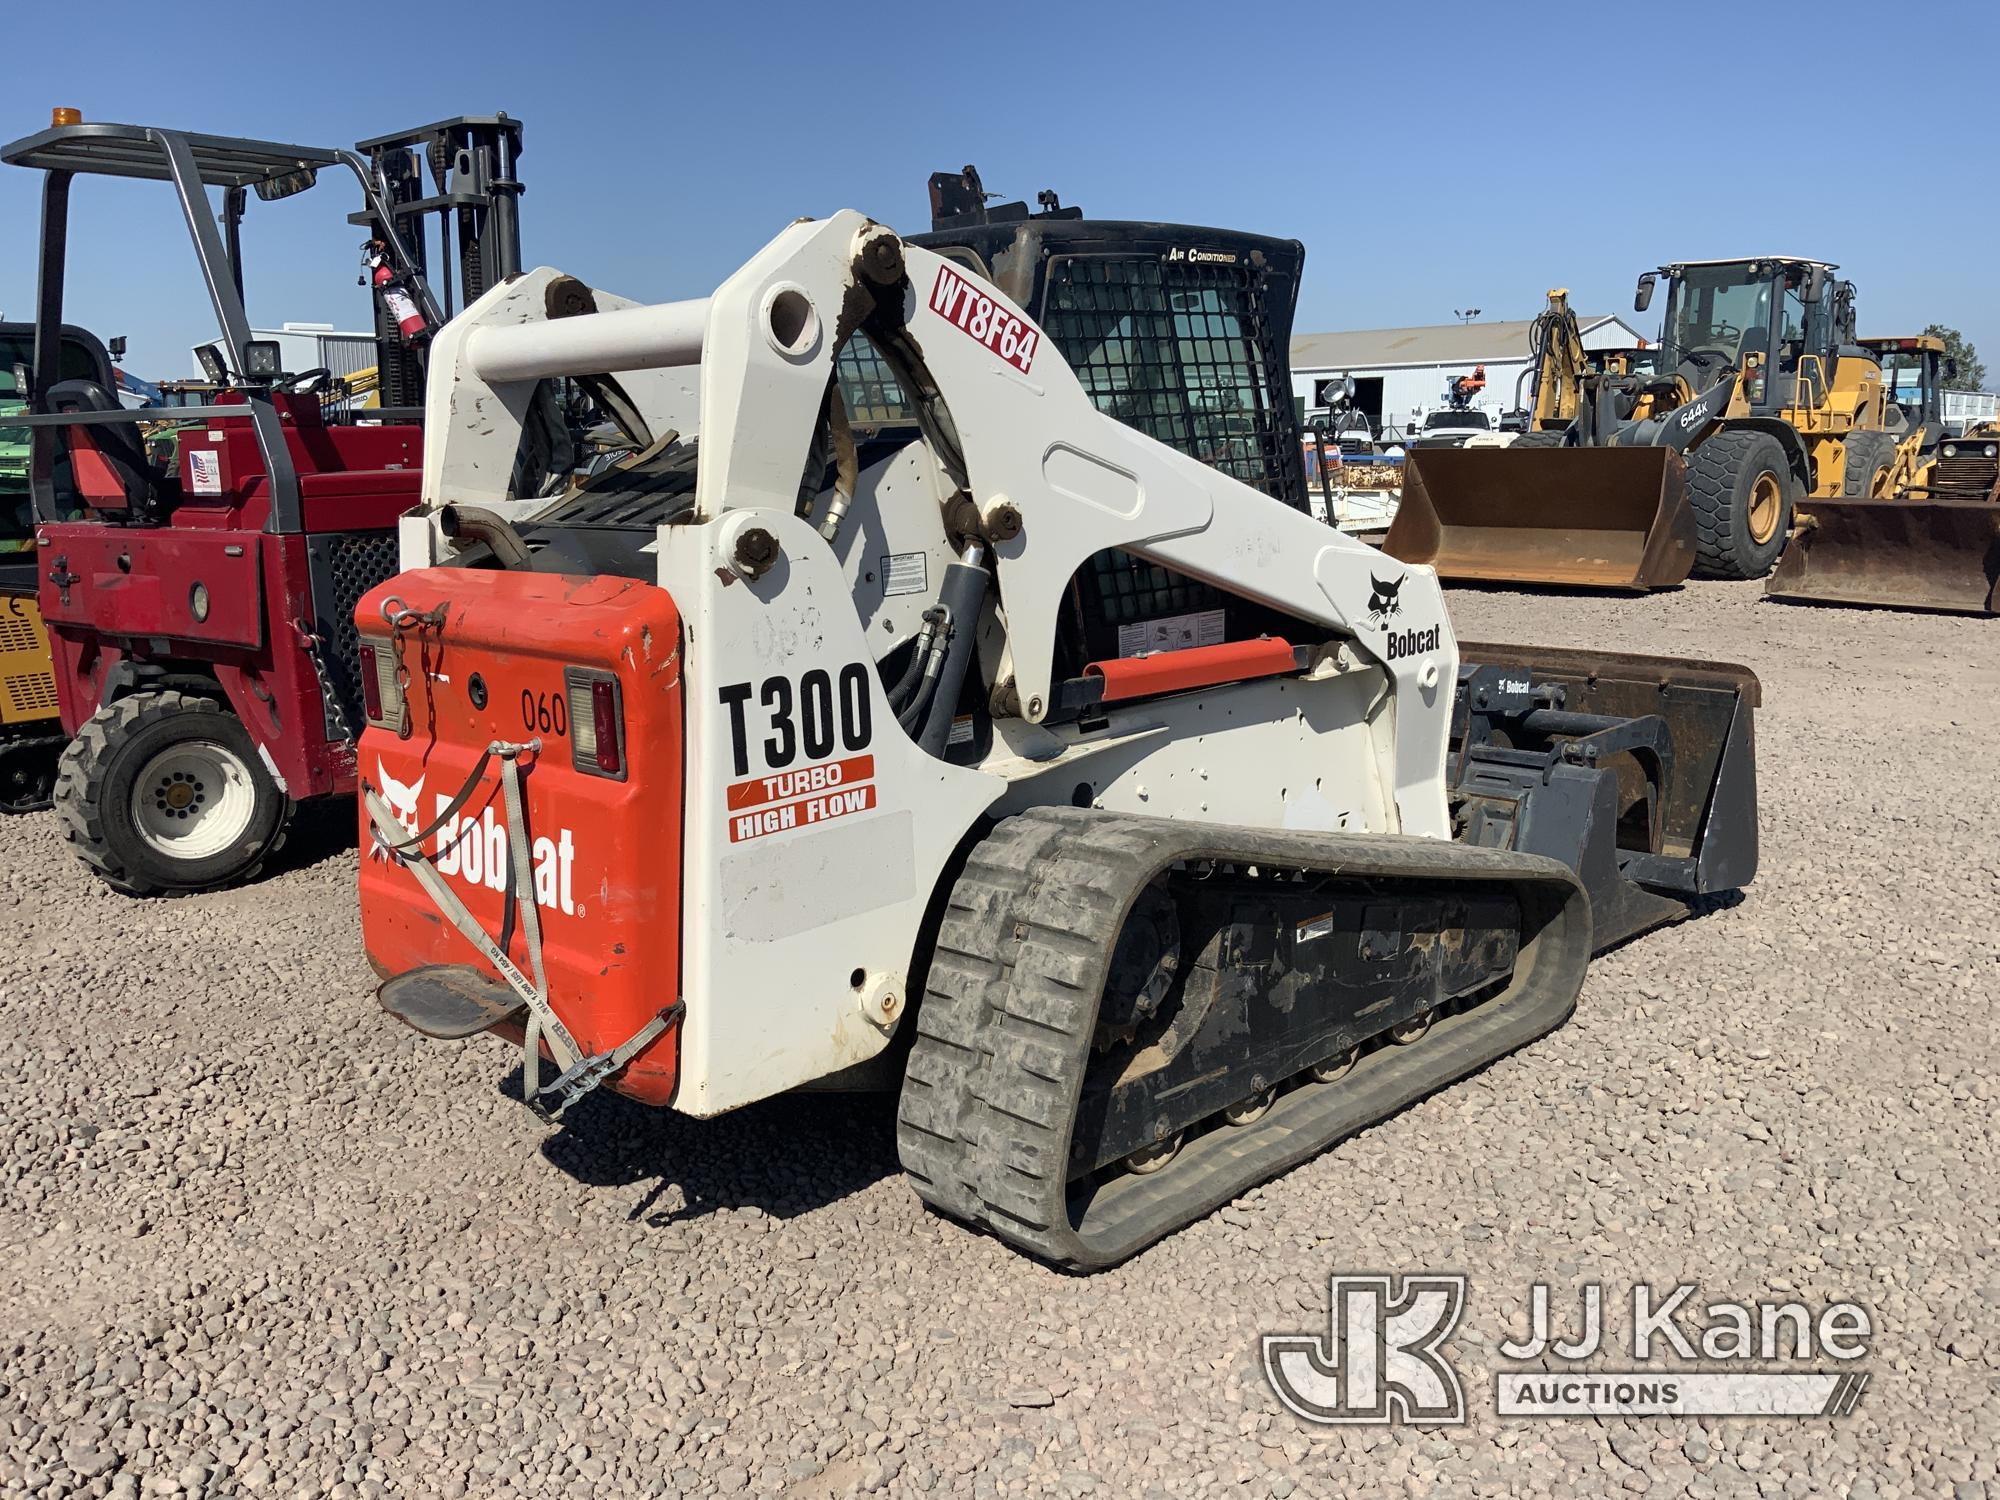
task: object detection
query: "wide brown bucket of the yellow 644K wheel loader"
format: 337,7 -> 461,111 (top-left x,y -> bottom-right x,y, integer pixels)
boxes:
1382,448 -> 1694,590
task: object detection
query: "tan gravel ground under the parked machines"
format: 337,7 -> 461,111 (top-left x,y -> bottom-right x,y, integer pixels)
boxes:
0,584 -> 2000,1500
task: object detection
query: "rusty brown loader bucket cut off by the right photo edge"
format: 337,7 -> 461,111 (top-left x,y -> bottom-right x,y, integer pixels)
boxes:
1764,500 -> 2000,614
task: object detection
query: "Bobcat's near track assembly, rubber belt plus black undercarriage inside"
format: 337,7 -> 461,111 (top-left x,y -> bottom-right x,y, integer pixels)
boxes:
896,808 -> 1592,1270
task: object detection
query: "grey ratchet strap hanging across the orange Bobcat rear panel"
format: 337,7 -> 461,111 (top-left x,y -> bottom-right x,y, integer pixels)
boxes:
362,740 -> 686,1120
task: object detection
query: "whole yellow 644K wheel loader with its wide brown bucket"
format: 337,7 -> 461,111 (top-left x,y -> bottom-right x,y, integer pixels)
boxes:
1386,256 -> 1894,590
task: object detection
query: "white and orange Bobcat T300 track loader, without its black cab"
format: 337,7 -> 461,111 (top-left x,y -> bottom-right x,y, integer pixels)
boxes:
358,212 -> 1756,1268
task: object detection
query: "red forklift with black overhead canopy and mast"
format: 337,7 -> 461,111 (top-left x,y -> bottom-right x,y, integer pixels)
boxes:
0,110 -> 522,896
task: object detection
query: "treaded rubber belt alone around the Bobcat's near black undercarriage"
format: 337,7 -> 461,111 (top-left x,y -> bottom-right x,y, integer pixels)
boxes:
896,808 -> 1590,1270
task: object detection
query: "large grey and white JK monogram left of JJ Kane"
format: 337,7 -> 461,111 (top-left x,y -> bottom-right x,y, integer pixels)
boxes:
1264,1276 -> 1466,1426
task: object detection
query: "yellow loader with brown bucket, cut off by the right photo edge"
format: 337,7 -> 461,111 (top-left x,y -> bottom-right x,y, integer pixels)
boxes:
1764,334 -> 2000,614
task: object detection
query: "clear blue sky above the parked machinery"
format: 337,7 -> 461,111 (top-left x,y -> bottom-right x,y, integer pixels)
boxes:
0,0 -> 2000,382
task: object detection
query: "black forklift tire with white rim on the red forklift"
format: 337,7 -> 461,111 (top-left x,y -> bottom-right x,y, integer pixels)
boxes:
56,690 -> 290,896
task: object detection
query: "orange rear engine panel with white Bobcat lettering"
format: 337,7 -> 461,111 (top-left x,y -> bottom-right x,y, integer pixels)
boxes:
356,568 -> 684,1104
